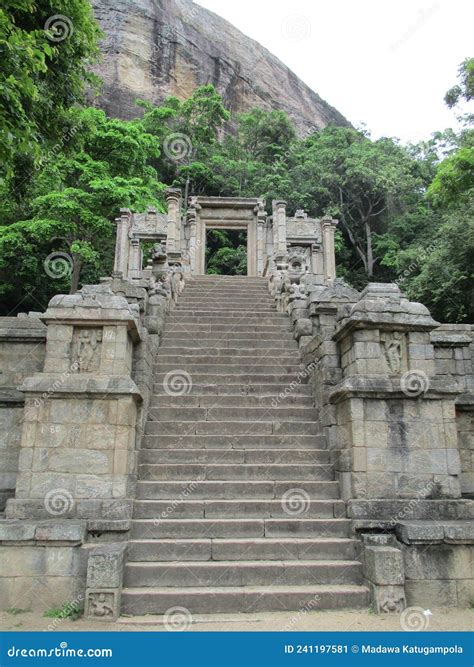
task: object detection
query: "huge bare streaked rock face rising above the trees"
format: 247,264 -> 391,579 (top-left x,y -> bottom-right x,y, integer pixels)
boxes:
92,0 -> 348,134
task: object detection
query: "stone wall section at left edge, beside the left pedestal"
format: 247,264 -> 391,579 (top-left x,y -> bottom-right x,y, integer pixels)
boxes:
0,317 -> 46,512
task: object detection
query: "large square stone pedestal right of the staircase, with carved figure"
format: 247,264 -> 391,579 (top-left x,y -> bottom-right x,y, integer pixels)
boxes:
330,283 -> 460,499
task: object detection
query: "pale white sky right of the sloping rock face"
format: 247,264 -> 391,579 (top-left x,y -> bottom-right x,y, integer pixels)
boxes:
198,0 -> 474,143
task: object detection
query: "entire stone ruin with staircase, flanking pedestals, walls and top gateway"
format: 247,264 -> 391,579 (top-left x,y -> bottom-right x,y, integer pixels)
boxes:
0,194 -> 474,622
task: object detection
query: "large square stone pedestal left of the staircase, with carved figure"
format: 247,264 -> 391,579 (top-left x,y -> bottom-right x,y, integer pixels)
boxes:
7,286 -> 141,529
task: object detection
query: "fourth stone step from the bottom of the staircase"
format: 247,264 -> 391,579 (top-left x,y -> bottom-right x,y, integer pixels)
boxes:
131,518 -> 351,539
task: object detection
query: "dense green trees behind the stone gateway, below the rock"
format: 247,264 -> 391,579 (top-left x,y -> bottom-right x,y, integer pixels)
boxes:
0,0 -> 474,321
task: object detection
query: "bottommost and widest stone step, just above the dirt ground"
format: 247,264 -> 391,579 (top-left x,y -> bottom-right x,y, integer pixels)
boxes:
122,584 -> 369,615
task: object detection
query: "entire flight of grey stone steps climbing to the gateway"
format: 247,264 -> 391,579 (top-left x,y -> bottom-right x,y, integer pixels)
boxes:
122,276 -> 368,615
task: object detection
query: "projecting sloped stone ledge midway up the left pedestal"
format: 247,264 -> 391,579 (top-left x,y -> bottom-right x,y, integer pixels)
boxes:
19,373 -> 142,401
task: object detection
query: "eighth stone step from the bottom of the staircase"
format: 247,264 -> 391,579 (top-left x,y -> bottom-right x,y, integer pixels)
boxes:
139,442 -> 330,464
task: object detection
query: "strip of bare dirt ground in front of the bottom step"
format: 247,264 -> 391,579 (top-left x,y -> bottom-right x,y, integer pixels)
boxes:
0,607 -> 474,632
